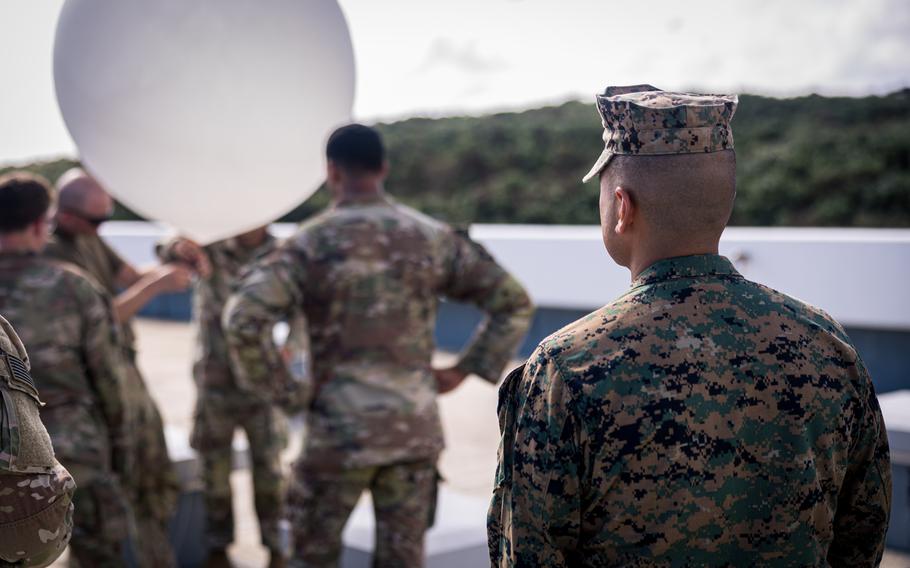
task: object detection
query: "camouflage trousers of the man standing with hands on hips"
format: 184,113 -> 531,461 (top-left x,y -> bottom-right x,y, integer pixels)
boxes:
288,460 -> 438,568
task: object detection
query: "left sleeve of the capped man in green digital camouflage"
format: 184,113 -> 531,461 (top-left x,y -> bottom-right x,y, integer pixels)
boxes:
489,351 -> 585,568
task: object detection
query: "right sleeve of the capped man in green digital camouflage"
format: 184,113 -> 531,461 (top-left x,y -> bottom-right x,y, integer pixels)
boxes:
828,361 -> 891,568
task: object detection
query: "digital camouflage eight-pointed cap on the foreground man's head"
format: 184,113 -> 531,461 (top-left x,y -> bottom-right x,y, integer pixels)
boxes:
582,85 -> 738,182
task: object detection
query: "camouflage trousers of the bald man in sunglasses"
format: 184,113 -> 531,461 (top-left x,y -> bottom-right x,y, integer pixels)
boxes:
123,362 -> 179,568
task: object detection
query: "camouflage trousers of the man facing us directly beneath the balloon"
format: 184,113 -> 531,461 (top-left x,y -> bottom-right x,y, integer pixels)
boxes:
190,389 -> 287,551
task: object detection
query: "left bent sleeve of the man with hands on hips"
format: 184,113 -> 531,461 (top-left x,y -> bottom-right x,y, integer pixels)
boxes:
222,249 -> 310,411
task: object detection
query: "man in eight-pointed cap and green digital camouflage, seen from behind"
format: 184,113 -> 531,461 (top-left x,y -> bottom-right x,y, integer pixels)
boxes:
488,86 -> 891,568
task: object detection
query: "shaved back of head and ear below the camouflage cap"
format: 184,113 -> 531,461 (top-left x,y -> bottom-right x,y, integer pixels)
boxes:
600,150 -> 736,266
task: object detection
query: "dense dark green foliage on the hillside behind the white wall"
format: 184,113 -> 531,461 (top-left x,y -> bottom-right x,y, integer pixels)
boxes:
3,89 -> 910,227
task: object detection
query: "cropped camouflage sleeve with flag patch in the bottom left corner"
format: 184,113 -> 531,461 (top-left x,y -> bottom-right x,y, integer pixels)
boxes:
0,316 -> 76,568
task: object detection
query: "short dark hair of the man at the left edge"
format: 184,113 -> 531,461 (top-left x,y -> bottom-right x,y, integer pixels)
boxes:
0,172 -> 54,234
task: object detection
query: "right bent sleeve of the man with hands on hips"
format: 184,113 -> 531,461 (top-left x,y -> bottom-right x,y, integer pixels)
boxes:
442,233 -> 534,383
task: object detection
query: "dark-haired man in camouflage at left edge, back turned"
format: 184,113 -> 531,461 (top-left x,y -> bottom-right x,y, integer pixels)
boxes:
0,174 -> 132,567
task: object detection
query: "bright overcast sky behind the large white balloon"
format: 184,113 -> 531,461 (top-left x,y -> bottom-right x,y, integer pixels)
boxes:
0,0 -> 910,163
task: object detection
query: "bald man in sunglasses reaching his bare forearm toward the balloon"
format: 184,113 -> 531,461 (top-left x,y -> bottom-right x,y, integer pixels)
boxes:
44,170 -> 188,568
